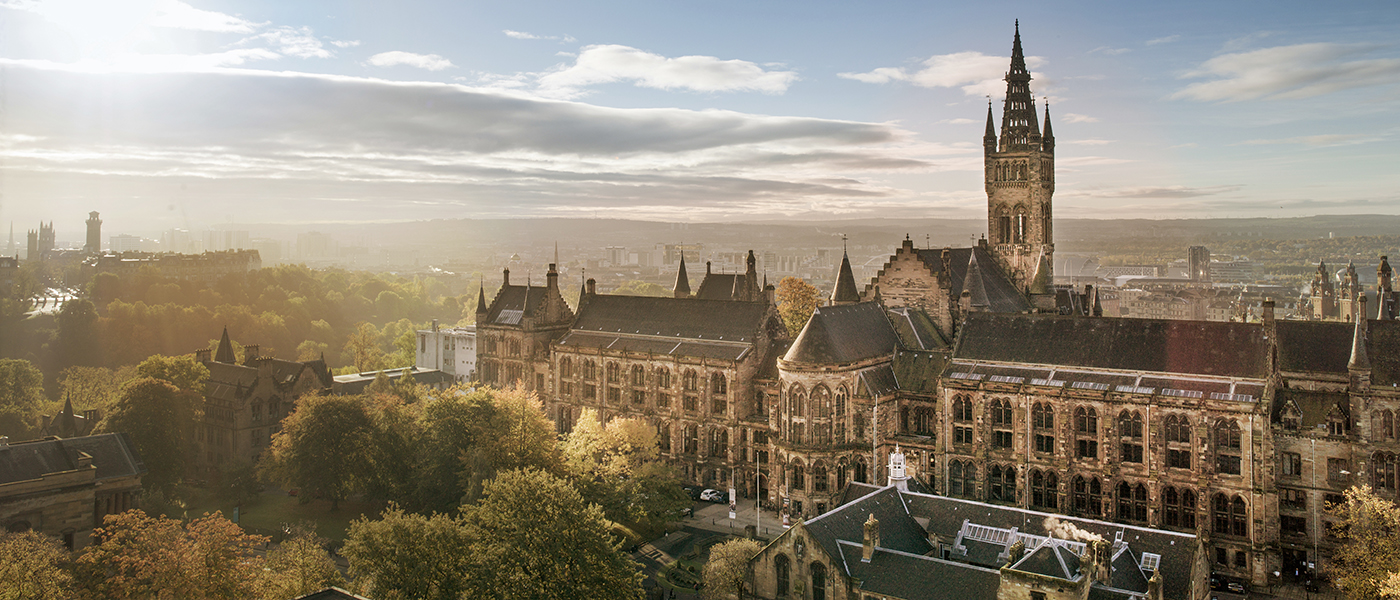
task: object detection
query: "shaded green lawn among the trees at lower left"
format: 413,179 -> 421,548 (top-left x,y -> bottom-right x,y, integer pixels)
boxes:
186,490 -> 384,541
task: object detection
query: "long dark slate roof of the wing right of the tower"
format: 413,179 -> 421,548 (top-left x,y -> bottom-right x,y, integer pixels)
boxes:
953,313 -> 1271,379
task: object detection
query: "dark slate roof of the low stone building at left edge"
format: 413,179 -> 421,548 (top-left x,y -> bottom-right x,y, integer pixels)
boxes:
0,432 -> 146,484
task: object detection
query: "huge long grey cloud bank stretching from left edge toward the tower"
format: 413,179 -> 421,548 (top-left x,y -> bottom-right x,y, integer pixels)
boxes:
0,60 -> 924,227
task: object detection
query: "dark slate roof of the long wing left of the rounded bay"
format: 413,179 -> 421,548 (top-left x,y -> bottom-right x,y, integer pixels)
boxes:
557,294 -> 769,359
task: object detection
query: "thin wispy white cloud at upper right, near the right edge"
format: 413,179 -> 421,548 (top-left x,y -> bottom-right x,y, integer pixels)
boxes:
1172,43 -> 1400,102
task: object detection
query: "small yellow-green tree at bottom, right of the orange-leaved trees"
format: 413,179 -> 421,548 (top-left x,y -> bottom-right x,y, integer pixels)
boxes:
256,527 -> 346,600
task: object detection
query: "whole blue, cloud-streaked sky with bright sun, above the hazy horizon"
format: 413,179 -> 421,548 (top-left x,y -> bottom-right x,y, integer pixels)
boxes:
0,0 -> 1400,243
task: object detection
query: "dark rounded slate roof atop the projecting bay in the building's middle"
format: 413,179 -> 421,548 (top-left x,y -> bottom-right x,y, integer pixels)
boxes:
783,302 -> 900,365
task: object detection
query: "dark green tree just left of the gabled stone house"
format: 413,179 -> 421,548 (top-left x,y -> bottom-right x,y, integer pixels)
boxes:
95,378 -> 199,492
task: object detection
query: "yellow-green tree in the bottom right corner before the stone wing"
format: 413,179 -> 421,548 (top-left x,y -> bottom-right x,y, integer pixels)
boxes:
1327,485 -> 1400,600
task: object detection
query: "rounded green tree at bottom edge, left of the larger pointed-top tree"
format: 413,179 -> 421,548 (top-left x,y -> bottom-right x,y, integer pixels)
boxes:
342,505 -> 486,600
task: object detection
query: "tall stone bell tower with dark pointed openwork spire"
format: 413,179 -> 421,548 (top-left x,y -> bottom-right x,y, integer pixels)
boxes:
981,21 -> 1054,291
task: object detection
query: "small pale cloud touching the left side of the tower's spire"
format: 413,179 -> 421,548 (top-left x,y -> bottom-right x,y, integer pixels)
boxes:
836,52 -> 1044,97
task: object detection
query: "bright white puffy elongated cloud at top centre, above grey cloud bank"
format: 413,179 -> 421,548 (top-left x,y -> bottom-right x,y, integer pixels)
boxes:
539,45 -> 798,97
